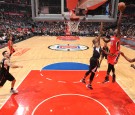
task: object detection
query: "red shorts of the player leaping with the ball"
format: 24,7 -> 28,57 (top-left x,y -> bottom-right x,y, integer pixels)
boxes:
107,52 -> 120,65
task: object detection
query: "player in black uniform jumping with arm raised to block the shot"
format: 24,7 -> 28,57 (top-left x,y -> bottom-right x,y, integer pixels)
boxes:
80,23 -> 103,90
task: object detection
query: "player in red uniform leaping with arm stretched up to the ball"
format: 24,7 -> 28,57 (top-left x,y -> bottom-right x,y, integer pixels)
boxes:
103,11 -> 122,83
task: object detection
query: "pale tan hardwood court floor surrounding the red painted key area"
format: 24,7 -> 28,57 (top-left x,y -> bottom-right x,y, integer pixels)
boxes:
0,36 -> 135,108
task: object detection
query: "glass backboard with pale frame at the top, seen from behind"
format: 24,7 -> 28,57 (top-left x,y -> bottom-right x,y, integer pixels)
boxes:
31,0 -> 119,22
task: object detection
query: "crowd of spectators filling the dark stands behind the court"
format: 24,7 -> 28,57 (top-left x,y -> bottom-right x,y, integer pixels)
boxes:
0,0 -> 135,49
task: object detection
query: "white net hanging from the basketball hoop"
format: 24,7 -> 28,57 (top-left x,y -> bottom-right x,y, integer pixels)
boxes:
67,20 -> 80,32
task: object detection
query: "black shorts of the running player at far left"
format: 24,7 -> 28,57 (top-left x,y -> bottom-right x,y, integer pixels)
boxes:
0,72 -> 15,86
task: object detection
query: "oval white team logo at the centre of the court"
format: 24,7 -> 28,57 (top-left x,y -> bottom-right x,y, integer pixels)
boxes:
48,44 -> 89,51
